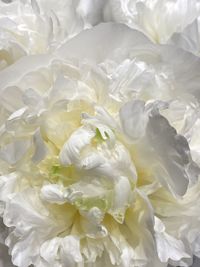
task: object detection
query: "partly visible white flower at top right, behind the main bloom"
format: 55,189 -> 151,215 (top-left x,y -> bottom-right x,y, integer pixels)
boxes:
105,0 -> 199,43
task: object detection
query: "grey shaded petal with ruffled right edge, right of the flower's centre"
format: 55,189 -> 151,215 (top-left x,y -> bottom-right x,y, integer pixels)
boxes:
147,114 -> 199,195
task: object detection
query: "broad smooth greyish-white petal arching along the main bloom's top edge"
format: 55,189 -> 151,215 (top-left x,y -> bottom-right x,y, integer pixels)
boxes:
57,23 -> 151,63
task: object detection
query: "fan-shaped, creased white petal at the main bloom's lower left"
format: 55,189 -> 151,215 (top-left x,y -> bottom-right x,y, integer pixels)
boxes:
4,188 -> 63,267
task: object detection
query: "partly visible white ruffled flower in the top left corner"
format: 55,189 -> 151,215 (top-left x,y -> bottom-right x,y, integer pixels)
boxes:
0,0 -> 93,69
